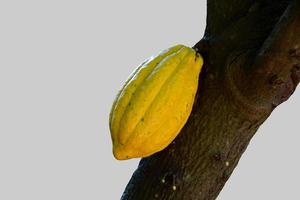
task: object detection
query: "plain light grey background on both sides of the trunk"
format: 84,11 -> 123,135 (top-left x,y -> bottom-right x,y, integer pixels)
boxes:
0,0 -> 300,200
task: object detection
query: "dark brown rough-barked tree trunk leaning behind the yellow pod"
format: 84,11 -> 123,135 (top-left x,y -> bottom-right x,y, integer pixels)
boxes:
121,0 -> 300,200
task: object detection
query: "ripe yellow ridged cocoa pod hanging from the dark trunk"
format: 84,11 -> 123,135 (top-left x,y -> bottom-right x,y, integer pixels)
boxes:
109,45 -> 203,160
